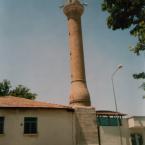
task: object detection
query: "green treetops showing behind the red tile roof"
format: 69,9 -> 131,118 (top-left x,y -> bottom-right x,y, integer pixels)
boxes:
0,80 -> 37,100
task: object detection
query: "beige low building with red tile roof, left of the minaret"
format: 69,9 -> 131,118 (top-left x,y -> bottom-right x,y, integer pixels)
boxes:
0,97 -> 75,145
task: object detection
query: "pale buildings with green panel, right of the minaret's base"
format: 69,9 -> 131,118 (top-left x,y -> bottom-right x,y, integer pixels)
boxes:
96,111 -> 145,145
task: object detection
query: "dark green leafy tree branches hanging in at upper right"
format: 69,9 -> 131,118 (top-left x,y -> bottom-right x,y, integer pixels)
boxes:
102,0 -> 145,94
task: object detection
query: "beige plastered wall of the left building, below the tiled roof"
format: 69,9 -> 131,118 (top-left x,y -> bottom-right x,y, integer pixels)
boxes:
0,109 -> 75,145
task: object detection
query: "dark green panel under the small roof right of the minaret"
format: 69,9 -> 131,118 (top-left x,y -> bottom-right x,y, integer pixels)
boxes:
97,116 -> 121,126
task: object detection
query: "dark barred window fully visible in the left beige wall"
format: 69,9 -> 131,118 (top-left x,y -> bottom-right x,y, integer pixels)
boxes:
24,117 -> 37,134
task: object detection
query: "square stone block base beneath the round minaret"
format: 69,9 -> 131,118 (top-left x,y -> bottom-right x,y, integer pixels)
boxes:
74,107 -> 98,145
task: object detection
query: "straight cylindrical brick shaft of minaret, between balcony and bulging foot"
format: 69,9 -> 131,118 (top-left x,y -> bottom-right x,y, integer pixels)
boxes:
68,18 -> 86,83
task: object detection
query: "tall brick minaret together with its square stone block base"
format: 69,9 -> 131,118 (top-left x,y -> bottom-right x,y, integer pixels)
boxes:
63,0 -> 98,145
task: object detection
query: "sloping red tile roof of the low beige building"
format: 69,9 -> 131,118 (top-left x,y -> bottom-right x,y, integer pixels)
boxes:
0,96 -> 73,110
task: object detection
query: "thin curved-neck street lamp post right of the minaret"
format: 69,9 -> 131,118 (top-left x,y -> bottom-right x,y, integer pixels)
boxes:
111,64 -> 123,145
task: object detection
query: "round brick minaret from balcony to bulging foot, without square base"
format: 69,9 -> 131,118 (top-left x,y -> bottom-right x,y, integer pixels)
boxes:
63,0 -> 91,106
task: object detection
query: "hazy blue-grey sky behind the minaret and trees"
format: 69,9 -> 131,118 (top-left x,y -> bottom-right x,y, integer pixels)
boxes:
0,0 -> 145,116
